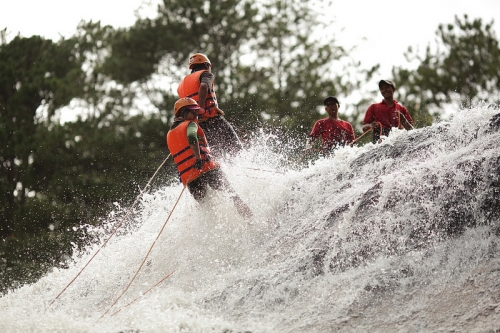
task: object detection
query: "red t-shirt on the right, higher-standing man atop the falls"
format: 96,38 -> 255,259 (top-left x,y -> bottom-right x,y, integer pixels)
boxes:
363,100 -> 413,129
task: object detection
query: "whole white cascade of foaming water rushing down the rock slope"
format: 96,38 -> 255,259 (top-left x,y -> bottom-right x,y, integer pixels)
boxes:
0,106 -> 500,333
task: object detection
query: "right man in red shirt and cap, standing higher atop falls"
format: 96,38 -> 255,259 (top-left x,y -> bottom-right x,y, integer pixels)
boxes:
363,80 -> 413,143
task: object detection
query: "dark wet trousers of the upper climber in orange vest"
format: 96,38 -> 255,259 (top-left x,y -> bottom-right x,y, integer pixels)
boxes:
199,116 -> 243,159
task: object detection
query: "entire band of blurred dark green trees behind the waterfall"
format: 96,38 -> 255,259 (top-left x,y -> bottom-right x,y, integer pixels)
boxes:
0,0 -> 500,291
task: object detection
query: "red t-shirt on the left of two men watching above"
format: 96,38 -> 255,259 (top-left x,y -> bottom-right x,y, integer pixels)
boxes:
309,118 -> 355,149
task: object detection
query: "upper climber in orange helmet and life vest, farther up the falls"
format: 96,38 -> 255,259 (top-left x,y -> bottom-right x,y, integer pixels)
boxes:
177,53 -> 243,158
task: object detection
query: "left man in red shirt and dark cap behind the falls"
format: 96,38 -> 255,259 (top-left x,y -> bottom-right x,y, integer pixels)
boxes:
306,96 -> 356,153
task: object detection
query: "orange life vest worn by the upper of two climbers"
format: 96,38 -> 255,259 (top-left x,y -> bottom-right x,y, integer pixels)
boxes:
177,71 -> 224,121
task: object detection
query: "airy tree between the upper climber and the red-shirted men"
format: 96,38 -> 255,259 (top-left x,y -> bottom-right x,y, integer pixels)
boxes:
223,0 -> 353,135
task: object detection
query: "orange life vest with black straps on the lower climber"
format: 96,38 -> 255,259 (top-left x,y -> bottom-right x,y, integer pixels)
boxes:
166,120 -> 219,185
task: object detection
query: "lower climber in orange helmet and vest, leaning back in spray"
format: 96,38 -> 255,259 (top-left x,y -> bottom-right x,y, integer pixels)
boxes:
166,98 -> 253,218
